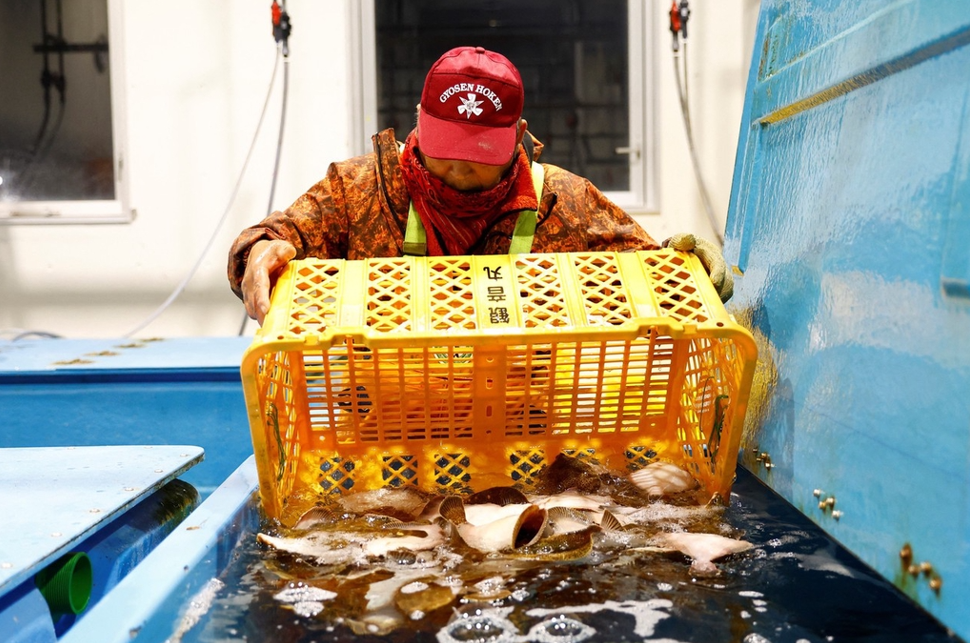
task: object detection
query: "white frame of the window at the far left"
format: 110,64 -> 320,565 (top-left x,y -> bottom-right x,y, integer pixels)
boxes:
0,0 -> 134,226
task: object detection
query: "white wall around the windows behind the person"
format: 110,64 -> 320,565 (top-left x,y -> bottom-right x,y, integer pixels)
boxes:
0,0 -> 757,338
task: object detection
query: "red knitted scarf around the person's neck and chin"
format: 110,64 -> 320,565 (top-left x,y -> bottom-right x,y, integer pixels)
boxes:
401,132 -> 538,257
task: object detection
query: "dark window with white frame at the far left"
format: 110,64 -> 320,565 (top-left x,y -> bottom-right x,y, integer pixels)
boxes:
0,0 -> 130,224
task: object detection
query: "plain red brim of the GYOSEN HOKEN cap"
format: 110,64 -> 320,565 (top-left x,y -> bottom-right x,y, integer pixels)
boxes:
418,110 -> 518,165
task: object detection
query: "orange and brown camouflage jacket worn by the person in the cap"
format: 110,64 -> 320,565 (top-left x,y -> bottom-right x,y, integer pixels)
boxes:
228,129 -> 659,298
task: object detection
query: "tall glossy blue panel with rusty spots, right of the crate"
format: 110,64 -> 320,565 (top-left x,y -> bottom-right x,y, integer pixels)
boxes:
725,0 -> 970,638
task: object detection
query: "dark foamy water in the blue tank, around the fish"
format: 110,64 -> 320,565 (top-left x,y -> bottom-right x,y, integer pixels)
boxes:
170,468 -> 959,643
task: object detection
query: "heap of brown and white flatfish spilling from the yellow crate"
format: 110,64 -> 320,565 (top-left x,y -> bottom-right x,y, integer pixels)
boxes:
251,454 -> 753,634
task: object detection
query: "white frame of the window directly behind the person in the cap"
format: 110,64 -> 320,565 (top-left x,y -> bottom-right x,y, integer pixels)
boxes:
351,0 -> 659,215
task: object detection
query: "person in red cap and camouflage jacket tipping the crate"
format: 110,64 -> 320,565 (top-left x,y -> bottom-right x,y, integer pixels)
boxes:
228,47 -> 732,325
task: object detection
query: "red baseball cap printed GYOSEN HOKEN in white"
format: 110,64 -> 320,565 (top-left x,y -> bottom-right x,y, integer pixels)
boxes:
418,47 -> 525,165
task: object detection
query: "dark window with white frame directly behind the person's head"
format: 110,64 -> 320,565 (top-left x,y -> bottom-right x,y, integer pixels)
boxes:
358,0 -> 656,212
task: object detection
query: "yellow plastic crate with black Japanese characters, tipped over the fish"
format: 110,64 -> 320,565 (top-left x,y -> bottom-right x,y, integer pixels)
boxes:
242,249 -> 757,525
